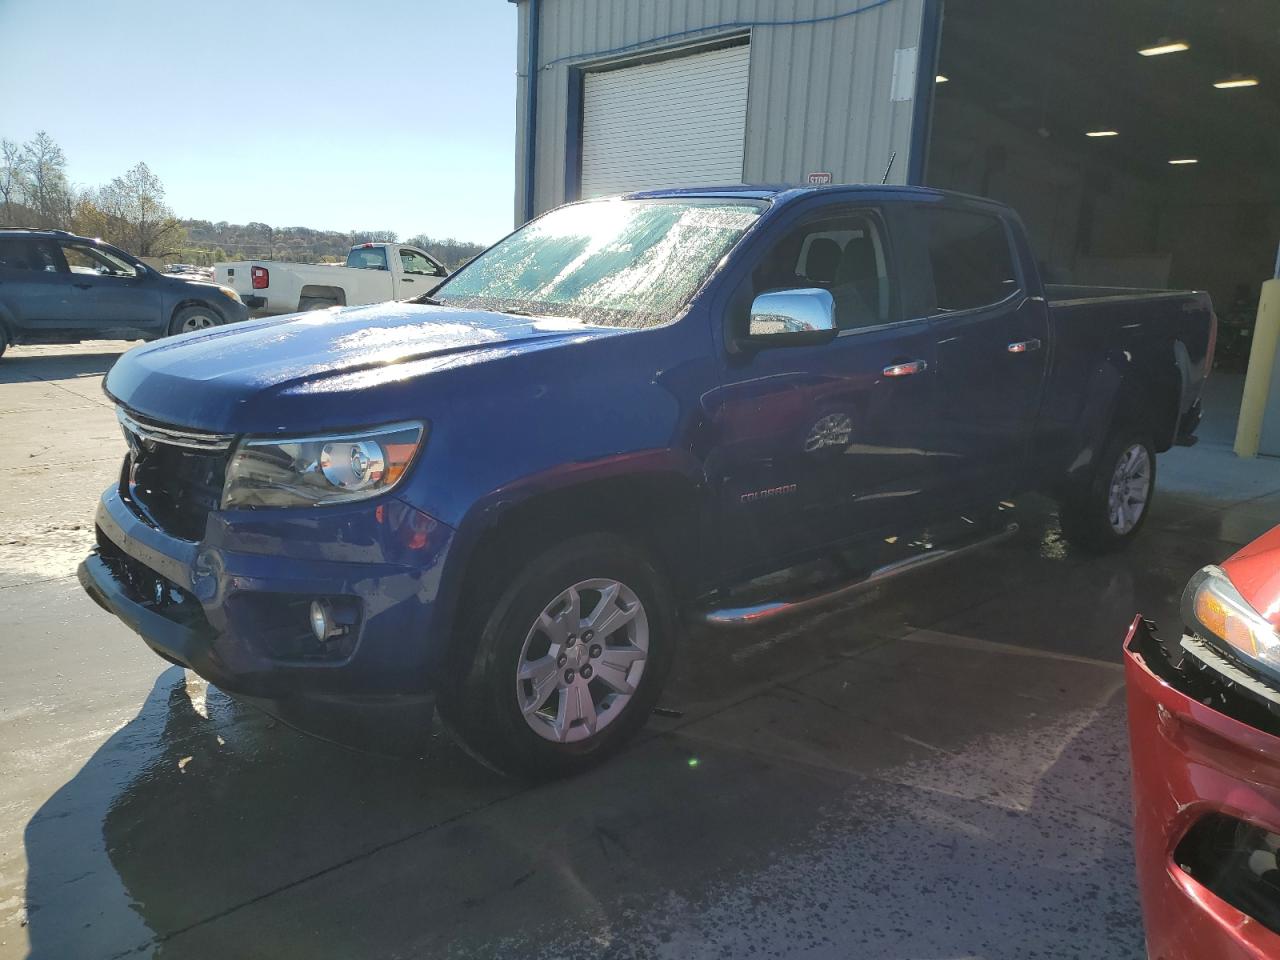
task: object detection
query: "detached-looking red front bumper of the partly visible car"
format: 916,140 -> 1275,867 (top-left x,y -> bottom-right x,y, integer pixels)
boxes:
1124,617 -> 1280,960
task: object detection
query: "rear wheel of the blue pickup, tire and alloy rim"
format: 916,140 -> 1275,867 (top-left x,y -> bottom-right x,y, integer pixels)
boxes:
1060,426 -> 1156,553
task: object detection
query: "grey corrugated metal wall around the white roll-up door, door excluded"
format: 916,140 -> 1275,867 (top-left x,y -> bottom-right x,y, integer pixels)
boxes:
516,0 -> 925,223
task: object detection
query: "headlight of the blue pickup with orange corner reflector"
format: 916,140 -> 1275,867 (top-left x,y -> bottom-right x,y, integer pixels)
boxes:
223,422 -> 426,509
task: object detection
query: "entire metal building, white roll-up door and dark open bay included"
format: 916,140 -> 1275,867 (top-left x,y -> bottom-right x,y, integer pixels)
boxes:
513,0 -> 1280,343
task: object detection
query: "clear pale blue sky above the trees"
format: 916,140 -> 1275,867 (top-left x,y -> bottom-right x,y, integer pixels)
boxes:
0,0 -> 516,243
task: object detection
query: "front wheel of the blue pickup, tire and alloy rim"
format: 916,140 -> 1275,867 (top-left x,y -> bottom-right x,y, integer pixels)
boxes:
436,534 -> 676,780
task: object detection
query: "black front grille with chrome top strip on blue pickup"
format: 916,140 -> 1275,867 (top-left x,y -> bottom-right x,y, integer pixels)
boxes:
116,410 -> 234,541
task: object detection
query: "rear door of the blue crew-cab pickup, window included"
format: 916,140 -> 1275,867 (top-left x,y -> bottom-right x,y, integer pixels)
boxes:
914,204 -> 1048,508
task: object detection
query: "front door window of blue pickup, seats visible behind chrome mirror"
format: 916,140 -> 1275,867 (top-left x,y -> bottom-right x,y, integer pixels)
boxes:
753,212 -> 896,330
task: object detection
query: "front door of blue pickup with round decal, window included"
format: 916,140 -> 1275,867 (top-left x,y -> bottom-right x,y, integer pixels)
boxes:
709,206 -> 936,570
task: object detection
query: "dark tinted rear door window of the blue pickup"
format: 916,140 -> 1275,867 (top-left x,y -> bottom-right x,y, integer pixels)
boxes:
922,207 -> 1018,312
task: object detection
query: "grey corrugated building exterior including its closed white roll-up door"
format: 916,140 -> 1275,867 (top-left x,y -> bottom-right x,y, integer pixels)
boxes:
513,0 -> 940,223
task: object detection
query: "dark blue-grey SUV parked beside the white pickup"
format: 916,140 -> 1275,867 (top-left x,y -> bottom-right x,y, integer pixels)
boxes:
0,229 -> 248,355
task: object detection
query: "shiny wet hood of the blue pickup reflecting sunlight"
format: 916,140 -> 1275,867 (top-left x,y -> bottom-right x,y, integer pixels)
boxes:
104,302 -> 626,434
